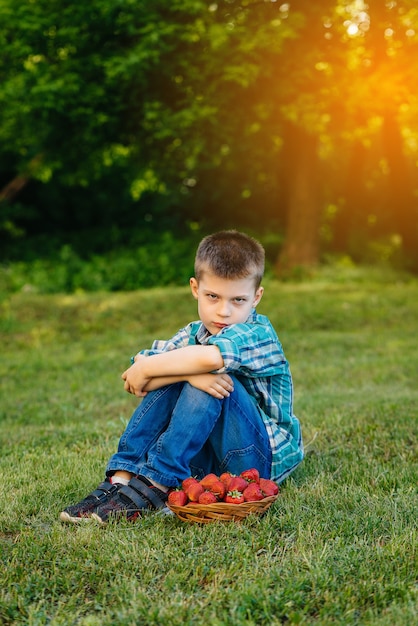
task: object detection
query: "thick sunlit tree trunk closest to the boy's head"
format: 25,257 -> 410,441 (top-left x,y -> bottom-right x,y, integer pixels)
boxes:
276,124 -> 321,274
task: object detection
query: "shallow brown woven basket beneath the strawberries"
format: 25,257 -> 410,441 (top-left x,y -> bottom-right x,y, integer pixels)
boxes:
168,496 -> 277,524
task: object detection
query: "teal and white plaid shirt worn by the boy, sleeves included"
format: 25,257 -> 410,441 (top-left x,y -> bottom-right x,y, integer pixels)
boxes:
141,309 -> 303,482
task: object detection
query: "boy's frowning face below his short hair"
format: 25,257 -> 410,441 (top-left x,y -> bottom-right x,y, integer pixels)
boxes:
190,272 -> 264,335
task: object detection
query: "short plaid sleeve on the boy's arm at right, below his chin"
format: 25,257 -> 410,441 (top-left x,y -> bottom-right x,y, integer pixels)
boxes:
208,323 -> 286,378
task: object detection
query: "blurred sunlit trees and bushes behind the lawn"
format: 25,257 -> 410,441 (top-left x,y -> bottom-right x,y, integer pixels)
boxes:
0,0 -> 418,292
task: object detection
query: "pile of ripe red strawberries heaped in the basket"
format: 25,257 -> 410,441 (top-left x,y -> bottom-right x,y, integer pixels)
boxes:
168,468 -> 279,506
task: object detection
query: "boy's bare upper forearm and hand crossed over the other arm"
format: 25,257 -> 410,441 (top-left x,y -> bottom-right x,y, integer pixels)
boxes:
122,346 -> 223,396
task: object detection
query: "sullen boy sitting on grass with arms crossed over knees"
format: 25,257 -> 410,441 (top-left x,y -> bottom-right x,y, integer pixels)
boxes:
60,231 -> 303,524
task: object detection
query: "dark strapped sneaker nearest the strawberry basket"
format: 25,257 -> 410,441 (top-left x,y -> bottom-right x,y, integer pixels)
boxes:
91,476 -> 168,526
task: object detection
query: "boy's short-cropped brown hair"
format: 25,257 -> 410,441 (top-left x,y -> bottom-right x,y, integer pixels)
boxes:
194,230 -> 265,289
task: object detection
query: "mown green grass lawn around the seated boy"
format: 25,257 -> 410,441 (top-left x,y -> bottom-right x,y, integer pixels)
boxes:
0,270 -> 418,626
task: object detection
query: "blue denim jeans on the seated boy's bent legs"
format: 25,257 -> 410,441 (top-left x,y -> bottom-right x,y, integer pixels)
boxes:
106,379 -> 271,487
